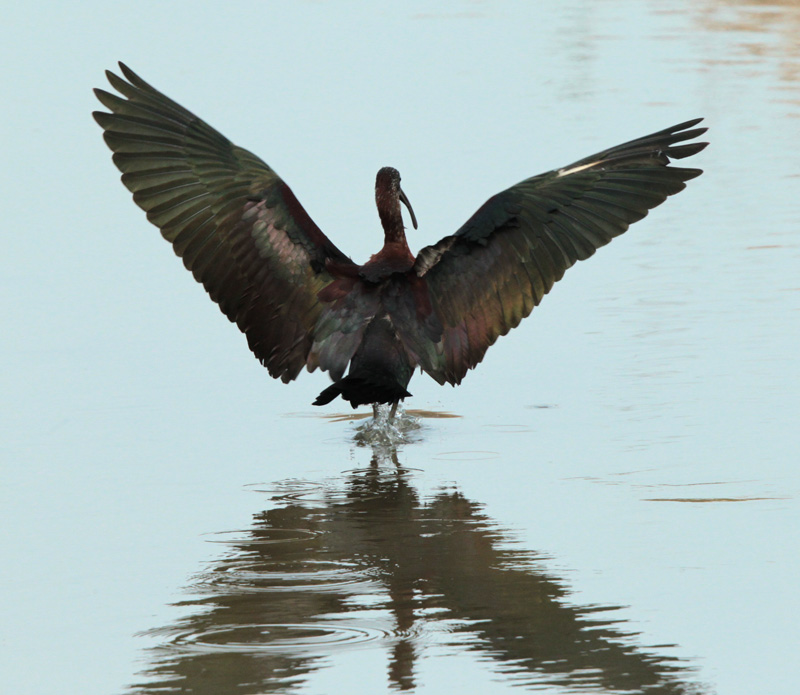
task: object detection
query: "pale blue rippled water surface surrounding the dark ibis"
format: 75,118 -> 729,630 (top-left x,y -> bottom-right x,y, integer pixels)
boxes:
0,0 -> 800,695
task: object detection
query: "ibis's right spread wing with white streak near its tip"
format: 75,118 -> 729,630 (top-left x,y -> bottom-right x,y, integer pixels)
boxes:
414,118 -> 708,384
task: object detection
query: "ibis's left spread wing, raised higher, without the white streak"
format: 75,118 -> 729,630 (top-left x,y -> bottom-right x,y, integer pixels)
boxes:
94,63 -> 352,381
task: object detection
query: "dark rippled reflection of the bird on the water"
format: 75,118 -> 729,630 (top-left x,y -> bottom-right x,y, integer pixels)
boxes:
132,438 -> 691,694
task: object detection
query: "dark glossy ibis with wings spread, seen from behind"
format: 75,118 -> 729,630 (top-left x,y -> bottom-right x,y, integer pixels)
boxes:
93,62 -> 708,417
